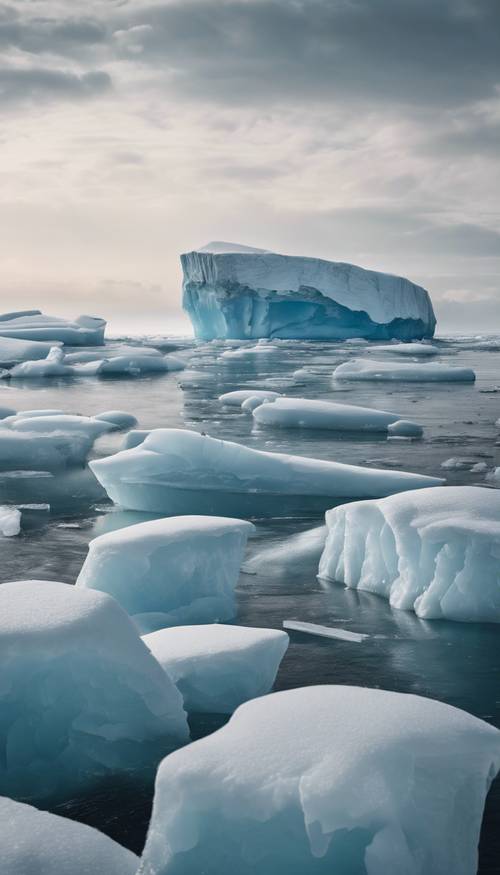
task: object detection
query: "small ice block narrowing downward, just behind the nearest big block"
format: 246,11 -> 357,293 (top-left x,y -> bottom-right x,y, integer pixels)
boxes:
143,623 -> 288,714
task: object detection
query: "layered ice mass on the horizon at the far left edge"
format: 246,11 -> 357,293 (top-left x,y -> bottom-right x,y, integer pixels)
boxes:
0,310 -> 106,344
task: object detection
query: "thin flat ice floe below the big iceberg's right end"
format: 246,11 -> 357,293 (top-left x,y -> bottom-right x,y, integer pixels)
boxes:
333,359 -> 476,383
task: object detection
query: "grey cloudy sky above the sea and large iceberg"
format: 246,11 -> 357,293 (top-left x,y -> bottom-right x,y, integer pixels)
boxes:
0,0 -> 500,332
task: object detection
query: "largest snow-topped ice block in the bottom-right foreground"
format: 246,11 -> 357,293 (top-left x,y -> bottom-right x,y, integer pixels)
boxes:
139,686 -> 500,875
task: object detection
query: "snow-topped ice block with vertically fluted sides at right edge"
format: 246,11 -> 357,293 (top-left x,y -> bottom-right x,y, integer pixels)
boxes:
319,486 -> 500,623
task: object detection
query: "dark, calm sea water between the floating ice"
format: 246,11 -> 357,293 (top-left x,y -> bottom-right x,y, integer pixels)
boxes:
0,336 -> 500,875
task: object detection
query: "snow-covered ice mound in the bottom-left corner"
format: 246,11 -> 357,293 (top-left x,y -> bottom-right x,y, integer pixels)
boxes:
0,797 -> 139,875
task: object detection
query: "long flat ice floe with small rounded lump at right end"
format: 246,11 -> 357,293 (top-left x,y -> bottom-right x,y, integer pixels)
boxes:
253,398 -> 422,434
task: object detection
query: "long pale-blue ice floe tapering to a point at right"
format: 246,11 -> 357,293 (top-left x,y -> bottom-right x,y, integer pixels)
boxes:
89,428 -> 443,517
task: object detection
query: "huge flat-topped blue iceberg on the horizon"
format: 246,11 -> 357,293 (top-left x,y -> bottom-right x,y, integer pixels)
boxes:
181,243 -> 436,340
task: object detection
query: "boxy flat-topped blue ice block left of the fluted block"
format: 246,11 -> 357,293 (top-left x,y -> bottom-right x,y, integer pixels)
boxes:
77,516 -> 254,631
